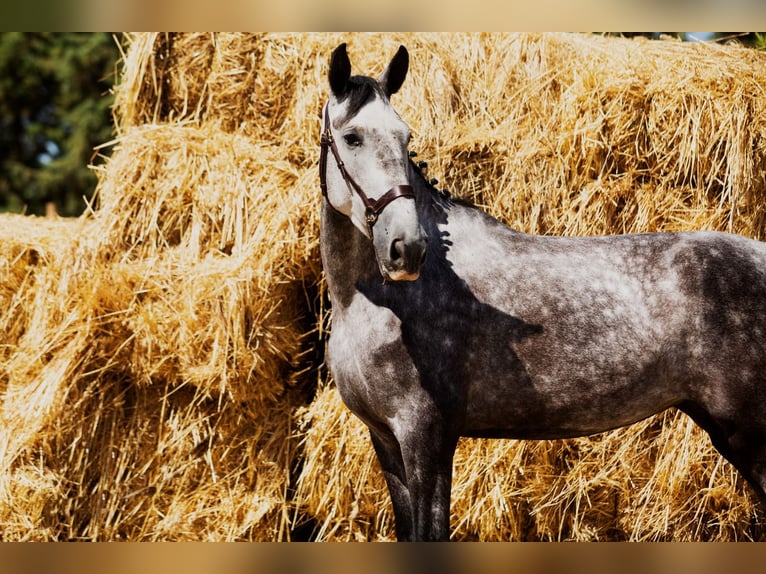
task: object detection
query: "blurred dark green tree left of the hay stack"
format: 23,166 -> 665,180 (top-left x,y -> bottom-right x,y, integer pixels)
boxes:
0,32 -> 119,215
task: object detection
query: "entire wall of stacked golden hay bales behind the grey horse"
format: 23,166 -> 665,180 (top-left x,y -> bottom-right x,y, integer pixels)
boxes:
0,34 -> 766,540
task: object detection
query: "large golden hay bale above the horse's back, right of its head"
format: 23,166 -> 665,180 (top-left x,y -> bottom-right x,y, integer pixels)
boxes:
404,34 -> 766,237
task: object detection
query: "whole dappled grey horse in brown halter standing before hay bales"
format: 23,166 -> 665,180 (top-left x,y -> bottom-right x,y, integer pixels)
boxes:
319,43 -> 766,540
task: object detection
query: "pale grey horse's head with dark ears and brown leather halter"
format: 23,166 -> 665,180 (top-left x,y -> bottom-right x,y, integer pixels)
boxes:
320,44 -> 426,281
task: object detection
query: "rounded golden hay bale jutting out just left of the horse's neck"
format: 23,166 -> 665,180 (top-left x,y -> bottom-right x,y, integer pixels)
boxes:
90,125 -> 319,412
